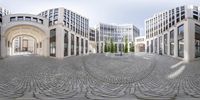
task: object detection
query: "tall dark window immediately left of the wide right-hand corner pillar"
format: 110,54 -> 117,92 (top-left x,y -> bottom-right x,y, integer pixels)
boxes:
178,25 -> 184,58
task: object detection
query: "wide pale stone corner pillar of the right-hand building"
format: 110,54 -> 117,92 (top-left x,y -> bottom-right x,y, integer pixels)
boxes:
184,19 -> 195,62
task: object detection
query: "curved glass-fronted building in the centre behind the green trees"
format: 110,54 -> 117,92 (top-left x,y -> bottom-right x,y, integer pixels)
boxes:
96,23 -> 140,53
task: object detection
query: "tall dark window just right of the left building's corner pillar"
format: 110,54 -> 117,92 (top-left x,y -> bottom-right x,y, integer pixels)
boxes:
64,30 -> 68,56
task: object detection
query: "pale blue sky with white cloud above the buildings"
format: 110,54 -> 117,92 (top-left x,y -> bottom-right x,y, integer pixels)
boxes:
0,0 -> 200,35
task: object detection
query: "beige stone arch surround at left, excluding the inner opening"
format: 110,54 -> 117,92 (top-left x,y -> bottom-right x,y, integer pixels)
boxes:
2,25 -> 48,57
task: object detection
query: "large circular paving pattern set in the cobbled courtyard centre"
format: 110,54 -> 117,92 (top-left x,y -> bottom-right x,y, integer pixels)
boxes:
84,55 -> 154,84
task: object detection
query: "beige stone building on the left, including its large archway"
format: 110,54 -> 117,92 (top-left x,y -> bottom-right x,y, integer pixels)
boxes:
0,8 -> 89,58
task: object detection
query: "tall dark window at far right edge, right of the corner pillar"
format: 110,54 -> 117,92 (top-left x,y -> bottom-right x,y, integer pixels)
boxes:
195,24 -> 200,58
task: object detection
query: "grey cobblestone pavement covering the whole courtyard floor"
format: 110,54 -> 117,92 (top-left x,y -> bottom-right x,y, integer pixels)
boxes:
0,53 -> 200,100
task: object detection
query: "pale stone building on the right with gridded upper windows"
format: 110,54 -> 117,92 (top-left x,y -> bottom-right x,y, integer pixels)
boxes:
145,5 -> 200,61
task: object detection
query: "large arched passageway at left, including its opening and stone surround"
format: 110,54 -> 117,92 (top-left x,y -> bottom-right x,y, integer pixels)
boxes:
4,25 -> 48,56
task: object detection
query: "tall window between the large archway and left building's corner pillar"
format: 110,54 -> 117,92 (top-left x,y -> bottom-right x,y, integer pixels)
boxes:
50,29 -> 56,57
